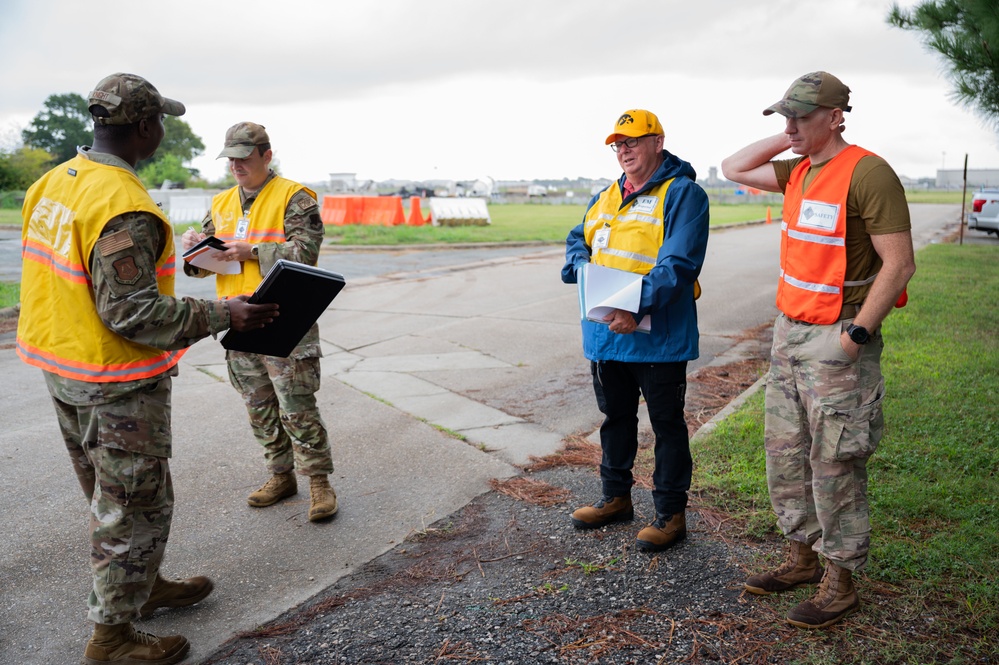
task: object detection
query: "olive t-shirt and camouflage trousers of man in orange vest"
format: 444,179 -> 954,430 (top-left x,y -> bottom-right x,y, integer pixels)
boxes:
765,150 -> 910,570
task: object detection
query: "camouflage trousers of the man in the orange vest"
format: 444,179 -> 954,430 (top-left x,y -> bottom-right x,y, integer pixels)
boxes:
764,314 -> 884,570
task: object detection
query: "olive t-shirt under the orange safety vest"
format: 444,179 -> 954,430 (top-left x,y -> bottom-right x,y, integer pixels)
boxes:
772,155 -> 912,305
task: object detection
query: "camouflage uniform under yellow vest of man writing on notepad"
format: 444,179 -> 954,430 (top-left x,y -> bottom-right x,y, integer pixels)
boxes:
184,171 -> 333,476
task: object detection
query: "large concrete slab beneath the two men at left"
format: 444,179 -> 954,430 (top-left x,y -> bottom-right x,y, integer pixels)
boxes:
0,338 -> 516,663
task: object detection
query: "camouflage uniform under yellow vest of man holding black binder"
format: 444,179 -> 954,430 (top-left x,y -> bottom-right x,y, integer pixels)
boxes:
44,148 -> 229,624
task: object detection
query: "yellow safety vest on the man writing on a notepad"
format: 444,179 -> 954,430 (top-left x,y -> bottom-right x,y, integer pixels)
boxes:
212,176 -> 316,298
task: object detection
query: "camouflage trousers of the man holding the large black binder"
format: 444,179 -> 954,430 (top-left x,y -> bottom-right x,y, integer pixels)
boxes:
52,377 -> 173,624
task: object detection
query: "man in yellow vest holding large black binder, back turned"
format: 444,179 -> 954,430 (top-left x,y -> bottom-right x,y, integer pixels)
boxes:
17,73 -> 277,665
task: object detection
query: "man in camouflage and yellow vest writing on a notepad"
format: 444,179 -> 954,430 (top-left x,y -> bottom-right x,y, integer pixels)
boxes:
182,122 -> 338,522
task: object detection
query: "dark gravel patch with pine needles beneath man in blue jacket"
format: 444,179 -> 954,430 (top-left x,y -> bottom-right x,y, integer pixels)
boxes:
197,460 -> 788,665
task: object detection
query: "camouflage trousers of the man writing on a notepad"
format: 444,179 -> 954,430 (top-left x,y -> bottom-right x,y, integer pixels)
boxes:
227,351 -> 333,476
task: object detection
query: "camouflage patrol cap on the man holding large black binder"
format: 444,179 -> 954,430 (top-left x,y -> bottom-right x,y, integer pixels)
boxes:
89,72 -> 187,125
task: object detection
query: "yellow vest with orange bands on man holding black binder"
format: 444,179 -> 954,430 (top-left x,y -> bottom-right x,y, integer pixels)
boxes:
17,156 -> 186,383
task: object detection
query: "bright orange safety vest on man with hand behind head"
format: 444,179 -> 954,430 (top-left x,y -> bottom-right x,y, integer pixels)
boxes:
777,145 -> 876,325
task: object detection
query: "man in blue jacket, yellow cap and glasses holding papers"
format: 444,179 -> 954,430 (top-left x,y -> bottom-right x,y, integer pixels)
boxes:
562,109 -> 708,552
